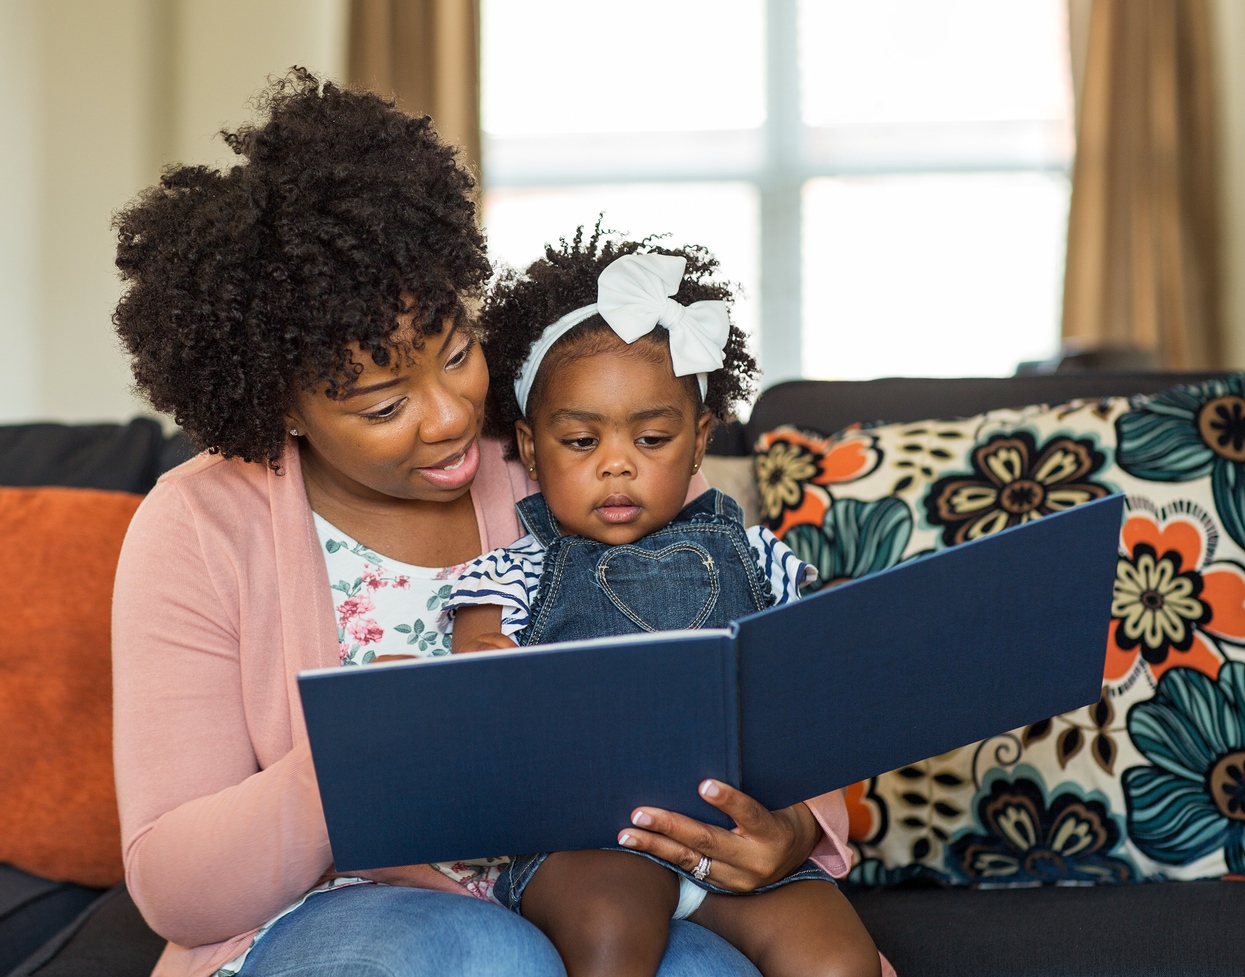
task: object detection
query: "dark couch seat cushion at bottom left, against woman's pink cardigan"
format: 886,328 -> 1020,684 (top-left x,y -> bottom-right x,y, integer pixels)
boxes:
9,885 -> 164,977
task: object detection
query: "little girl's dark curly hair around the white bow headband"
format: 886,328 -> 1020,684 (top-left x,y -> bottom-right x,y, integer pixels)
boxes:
478,220 -> 757,458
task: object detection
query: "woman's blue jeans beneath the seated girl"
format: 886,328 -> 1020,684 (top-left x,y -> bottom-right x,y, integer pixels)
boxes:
238,885 -> 759,977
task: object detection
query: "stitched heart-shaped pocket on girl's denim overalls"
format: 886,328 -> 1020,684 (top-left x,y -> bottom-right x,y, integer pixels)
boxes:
596,541 -> 721,631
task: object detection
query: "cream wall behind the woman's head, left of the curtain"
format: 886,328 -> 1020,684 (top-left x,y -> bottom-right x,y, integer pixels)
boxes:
0,0 -> 346,423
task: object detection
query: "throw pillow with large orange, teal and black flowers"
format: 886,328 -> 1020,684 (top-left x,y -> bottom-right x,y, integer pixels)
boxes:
754,376 -> 1245,886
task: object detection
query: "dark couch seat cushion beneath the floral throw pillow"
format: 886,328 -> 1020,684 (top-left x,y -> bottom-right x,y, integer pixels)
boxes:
849,881 -> 1245,977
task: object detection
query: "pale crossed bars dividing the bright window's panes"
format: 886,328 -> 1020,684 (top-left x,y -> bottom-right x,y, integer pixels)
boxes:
482,0 -> 1073,387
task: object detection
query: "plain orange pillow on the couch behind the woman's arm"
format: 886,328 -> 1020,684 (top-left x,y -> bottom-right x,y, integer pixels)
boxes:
0,488 -> 142,887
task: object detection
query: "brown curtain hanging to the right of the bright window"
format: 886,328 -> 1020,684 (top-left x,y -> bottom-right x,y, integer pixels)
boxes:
1063,0 -> 1220,370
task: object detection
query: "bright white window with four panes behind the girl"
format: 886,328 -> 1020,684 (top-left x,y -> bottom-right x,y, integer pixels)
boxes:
482,0 -> 1072,386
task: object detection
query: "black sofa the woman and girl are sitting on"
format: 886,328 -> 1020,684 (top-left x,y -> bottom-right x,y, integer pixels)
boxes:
0,373 -> 1245,977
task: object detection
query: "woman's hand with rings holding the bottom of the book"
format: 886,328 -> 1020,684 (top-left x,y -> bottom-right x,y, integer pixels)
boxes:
619,780 -> 822,892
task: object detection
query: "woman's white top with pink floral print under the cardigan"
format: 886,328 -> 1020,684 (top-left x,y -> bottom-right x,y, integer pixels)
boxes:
214,513 -> 509,977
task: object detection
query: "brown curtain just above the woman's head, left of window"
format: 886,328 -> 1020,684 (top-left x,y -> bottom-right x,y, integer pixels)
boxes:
349,0 -> 479,175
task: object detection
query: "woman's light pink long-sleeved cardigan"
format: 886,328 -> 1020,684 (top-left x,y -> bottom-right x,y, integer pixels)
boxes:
112,442 -> 850,977
